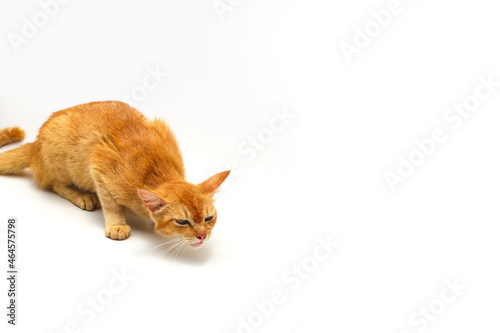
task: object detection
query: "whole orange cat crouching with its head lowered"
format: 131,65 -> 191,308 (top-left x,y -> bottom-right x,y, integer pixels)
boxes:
0,102 -> 230,247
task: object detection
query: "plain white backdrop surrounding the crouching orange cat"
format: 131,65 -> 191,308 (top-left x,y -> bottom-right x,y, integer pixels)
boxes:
0,0 -> 500,333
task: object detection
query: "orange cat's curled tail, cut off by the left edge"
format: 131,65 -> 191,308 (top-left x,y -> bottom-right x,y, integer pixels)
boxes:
0,127 -> 33,175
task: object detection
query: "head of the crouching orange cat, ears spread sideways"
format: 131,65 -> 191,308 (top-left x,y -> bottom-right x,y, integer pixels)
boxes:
137,171 -> 230,247
